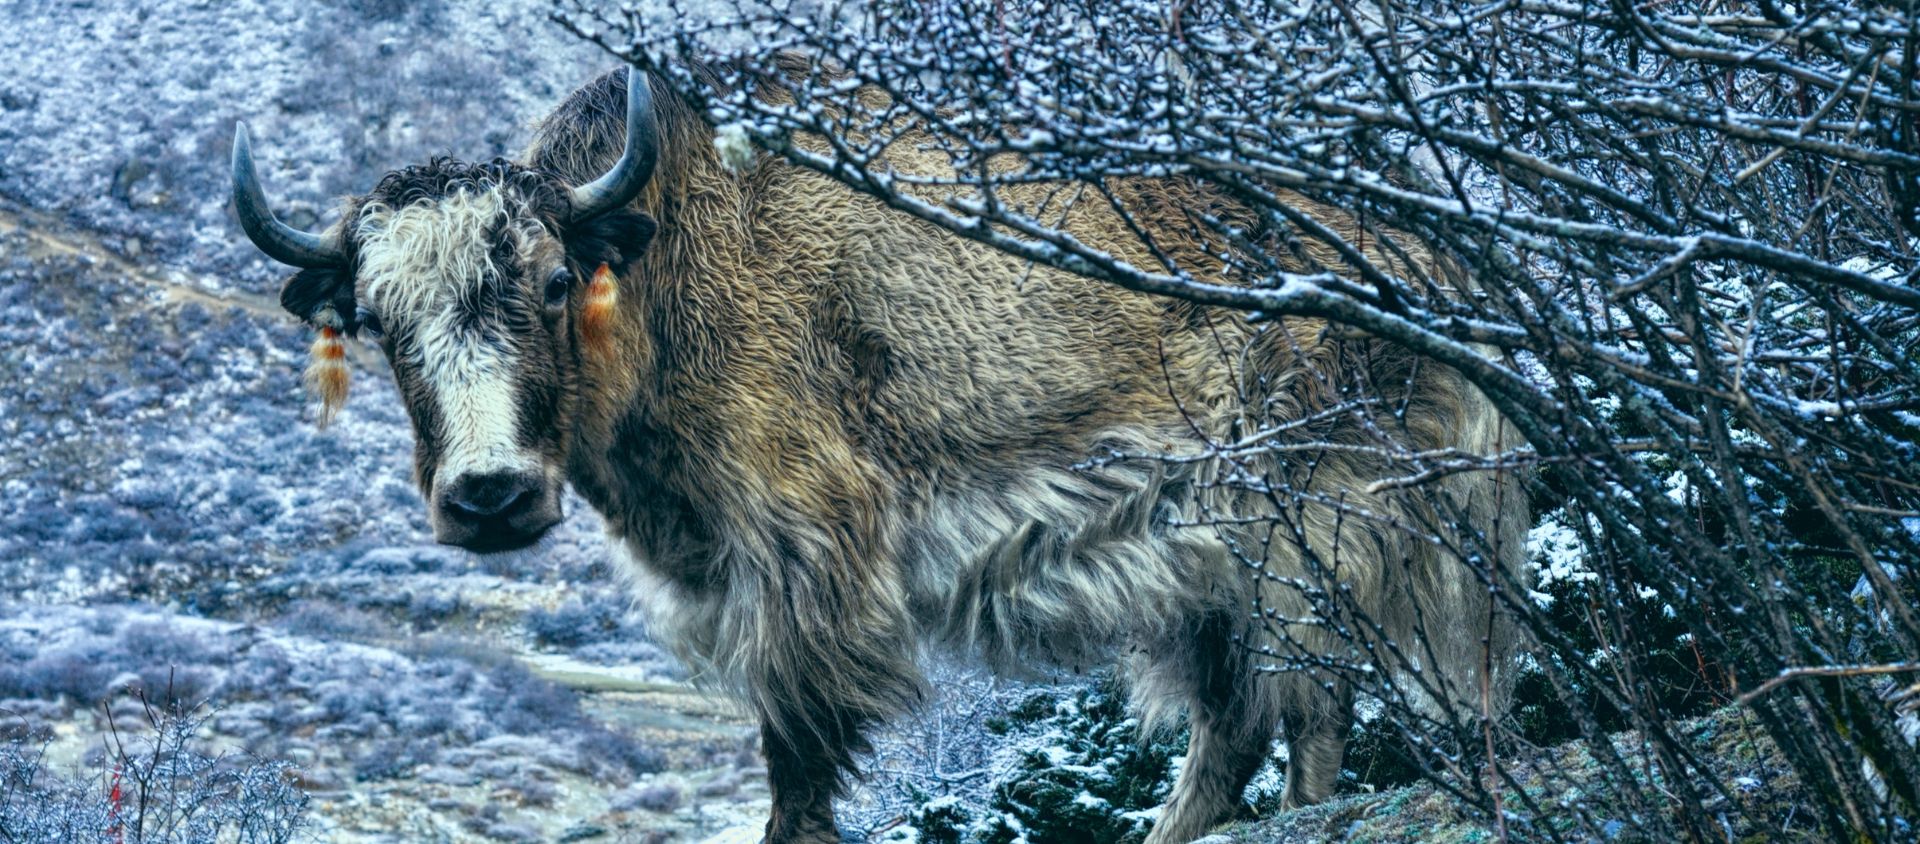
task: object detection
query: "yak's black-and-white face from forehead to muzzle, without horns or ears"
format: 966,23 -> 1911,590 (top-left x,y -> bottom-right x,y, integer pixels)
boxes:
353,175 -> 580,551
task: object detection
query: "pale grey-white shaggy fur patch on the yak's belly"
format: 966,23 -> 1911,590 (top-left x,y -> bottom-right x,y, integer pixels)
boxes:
900,435 -> 1242,669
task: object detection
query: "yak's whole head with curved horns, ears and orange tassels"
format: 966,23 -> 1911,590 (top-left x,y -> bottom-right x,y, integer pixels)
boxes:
232,73 -> 657,551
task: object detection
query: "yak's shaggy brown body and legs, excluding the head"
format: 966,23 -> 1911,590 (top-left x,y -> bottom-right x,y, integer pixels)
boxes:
510,67 -> 1526,842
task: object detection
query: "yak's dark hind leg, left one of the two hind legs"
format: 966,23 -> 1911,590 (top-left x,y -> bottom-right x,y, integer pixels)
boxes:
1146,620 -> 1275,844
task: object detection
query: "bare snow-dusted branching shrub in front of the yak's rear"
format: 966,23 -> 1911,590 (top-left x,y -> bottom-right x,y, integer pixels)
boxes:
557,0 -> 1920,840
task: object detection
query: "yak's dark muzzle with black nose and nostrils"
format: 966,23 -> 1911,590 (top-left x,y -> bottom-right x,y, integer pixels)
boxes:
434,472 -> 561,552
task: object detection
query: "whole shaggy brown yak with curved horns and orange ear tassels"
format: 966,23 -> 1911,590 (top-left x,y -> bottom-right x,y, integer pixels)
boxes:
232,62 -> 1524,844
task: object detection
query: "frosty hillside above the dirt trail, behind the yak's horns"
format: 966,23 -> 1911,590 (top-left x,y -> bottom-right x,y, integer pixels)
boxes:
0,0 -> 611,293
